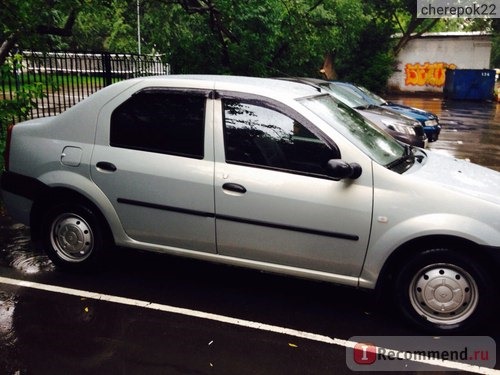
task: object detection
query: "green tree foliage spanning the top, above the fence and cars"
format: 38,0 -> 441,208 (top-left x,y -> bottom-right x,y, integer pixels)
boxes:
0,0 -> 496,90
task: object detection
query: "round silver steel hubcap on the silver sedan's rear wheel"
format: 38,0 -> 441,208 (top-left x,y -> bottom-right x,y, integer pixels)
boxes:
51,214 -> 93,262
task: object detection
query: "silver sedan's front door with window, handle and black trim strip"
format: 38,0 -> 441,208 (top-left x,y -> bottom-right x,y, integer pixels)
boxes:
215,95 -> 372,283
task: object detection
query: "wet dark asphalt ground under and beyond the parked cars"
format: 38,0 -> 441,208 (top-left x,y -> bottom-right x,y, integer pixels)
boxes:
0,97 -> 500,375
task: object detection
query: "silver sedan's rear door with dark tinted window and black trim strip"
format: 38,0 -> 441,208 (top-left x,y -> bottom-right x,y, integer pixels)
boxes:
91,88 -> 216,253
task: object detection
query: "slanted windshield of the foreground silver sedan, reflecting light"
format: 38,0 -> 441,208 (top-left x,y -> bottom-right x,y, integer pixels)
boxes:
299,95 -> 406,166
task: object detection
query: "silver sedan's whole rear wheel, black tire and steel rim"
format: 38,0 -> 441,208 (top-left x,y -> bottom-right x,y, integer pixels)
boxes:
41,203 -> 109,270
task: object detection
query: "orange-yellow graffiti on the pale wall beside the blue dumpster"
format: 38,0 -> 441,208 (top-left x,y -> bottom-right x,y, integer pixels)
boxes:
405,62 -> 457,87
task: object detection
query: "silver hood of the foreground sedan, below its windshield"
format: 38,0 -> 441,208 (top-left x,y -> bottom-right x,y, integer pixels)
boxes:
416,151 -> 500,205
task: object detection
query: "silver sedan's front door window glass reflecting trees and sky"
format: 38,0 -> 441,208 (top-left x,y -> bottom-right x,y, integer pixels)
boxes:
224,100 -> 338,175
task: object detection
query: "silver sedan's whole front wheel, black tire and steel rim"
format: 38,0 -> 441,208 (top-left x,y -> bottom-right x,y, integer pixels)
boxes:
394,248 -> 494,333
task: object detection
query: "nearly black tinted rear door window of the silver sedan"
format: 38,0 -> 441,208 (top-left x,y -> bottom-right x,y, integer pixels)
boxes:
110,91 -> 205,159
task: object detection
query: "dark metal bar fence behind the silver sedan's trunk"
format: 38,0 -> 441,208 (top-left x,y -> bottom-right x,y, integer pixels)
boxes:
0,51 -> 170,121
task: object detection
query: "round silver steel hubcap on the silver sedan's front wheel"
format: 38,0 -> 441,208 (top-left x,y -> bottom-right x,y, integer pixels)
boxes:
410,264 -> 478,325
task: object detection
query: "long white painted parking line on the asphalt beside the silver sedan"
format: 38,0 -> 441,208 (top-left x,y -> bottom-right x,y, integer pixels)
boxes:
0,277 -> 500,375
